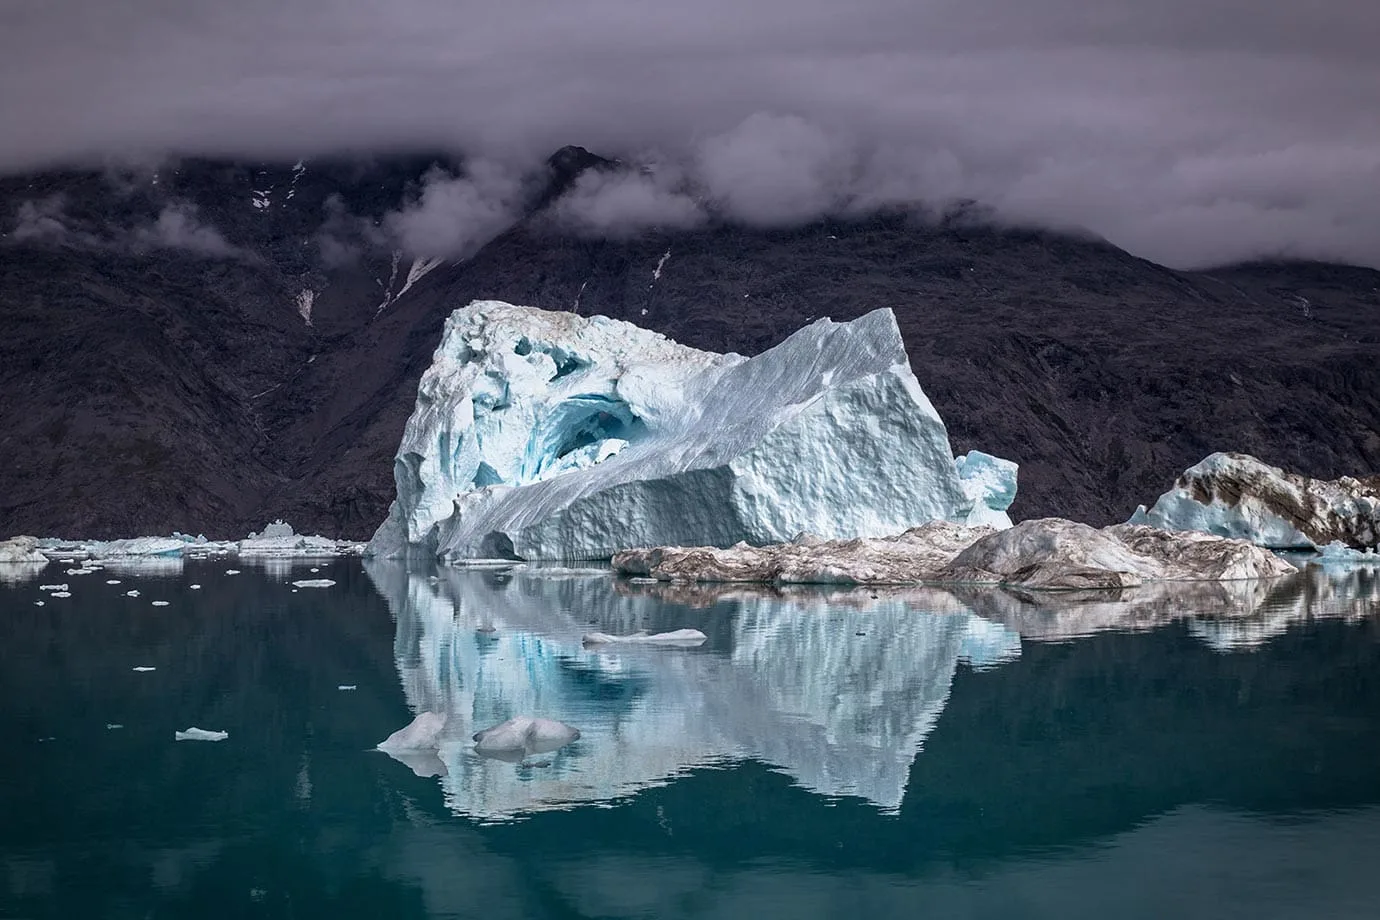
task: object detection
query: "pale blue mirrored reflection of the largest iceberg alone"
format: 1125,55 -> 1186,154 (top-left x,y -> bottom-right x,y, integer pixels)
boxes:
366,560 -> 1020,819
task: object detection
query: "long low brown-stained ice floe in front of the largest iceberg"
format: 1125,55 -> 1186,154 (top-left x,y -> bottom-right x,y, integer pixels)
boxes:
613,517 -> 1294,589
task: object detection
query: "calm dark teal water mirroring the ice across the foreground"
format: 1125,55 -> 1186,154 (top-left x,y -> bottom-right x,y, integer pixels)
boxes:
0,560 -> 1380,920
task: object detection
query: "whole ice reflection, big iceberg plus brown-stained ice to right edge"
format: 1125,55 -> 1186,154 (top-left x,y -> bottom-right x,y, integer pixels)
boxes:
366,560 -> 1380,819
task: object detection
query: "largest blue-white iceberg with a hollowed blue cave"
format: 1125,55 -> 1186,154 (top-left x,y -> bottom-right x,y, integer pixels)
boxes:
368,301 -> 1016,560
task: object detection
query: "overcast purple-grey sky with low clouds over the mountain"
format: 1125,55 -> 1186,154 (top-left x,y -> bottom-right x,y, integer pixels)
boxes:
0,0 -> 1380,266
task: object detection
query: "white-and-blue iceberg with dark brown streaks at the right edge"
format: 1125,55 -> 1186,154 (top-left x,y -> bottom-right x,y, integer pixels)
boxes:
1127,454 -> 1380,549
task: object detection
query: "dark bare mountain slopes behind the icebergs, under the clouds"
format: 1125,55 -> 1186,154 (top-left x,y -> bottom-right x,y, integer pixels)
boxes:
0,148 -> 1380,538
